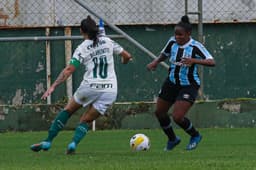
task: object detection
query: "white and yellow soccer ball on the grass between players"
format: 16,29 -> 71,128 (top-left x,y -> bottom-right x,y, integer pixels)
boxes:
130,133 -> 150,151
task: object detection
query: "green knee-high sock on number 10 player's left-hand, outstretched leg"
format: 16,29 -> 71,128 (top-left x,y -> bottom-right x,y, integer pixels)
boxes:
45,110 -> 70,142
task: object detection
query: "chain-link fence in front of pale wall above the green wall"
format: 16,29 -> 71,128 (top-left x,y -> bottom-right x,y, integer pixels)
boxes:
0,0 -> 256,27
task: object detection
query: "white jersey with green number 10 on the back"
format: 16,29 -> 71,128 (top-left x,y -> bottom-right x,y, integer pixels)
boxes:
70,37 -> 123,91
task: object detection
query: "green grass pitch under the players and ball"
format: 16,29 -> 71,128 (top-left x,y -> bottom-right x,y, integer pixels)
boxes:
0,128 -> 256,170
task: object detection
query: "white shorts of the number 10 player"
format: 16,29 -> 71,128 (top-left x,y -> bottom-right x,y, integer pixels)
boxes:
74,85 -> 117,115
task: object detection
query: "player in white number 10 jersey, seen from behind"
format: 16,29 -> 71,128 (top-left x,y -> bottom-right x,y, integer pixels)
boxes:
30,16 -> 132,154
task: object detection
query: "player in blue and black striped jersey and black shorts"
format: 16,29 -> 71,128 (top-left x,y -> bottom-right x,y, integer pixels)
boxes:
147,16 -> 215,150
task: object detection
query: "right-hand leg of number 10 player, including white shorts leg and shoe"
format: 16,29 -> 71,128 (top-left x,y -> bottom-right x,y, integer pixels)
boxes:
67,92 -> 116,154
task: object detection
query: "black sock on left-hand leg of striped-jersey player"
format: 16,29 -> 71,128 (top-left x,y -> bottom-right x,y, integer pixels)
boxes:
158,115 -> 176,141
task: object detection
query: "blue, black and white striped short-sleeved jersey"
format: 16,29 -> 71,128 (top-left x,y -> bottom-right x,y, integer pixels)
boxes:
161,37 -> 213,86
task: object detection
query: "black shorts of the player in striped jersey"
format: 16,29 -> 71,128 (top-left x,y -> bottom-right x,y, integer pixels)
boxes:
158,78 -> 199,104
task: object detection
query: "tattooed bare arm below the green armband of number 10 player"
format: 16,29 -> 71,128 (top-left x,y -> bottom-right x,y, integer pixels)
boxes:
41,64 -> 76,99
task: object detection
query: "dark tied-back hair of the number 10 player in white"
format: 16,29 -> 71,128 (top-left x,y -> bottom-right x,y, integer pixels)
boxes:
80,15 -> 99,47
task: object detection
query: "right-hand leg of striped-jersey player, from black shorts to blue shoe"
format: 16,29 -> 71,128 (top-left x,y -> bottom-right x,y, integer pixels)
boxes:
172,88 -> 202,150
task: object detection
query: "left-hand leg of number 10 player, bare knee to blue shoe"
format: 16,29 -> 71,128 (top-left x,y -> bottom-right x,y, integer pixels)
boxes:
30,98 -> 81,152
